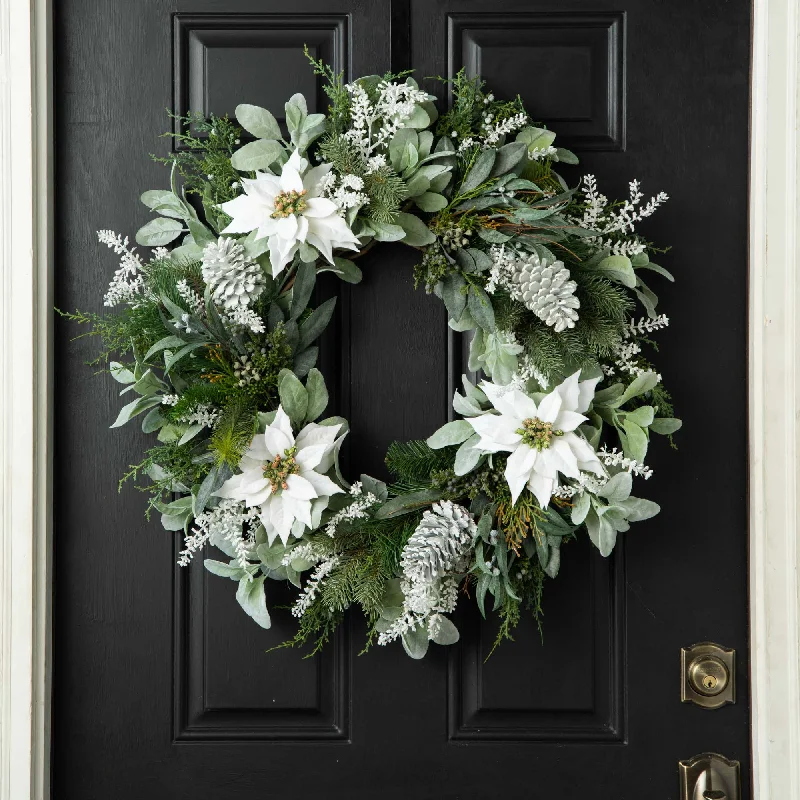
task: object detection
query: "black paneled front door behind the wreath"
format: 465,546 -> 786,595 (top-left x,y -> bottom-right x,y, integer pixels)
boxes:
53,0 -> 750,800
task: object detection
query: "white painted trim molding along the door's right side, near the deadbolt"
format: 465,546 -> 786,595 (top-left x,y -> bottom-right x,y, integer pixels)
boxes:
749,0 -> 800,800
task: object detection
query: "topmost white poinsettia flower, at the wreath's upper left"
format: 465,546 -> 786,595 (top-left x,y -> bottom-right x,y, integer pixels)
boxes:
220,150 -> 360,277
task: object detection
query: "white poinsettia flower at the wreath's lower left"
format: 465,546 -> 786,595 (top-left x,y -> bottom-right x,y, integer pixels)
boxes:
215,406 -> 343,544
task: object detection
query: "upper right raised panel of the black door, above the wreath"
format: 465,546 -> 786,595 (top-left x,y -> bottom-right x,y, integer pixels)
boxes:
447,11 -> 625,151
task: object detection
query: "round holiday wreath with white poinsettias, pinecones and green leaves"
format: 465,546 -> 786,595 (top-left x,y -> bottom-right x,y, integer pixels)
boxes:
67,54 -> 680,658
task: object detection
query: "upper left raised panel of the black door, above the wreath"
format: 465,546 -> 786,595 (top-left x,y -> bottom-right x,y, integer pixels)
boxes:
173,13 -> 349,149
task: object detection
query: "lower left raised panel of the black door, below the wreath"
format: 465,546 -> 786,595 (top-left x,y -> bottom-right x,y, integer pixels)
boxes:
173,551 -> 350,742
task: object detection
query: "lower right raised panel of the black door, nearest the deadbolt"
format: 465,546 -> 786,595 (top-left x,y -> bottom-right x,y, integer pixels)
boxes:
448,542 -> 625,743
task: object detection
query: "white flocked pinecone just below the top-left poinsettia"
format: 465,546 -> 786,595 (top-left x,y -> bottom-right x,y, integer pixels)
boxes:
203,236 -> 265,311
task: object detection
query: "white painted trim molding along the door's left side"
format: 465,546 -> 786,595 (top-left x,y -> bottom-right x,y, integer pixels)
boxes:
0,0 -> 53,800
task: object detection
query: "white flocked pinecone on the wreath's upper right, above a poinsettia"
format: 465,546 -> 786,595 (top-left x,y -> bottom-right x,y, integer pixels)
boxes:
513,253 -> 581,333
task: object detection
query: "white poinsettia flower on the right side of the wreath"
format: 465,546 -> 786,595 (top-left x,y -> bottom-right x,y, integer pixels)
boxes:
467,372 -> 605,508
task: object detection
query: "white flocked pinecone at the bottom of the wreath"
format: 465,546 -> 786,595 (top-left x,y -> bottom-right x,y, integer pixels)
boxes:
400,500 -> 476,584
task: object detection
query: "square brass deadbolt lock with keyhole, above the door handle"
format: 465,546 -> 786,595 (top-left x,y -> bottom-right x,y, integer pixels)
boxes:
681,642 -> 736,709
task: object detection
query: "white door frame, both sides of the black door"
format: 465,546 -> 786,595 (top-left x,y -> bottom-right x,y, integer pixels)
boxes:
0,0 -> 800,800
